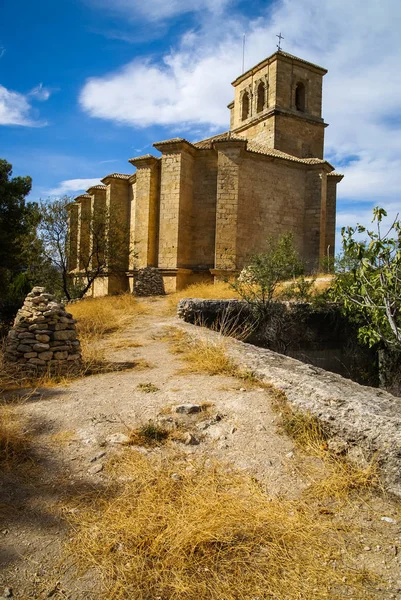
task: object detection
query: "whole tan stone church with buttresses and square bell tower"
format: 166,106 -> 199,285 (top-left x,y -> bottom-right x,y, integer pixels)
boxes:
69,50 -> 342,295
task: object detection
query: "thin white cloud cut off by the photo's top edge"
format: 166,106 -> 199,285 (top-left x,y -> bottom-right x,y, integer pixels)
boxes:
89,0 -> 232,21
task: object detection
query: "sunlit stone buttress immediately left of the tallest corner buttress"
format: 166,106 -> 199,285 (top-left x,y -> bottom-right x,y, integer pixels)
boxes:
129,154 -> 160,268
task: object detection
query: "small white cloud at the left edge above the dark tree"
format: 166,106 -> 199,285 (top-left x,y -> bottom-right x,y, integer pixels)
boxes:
0,84 -> 50,127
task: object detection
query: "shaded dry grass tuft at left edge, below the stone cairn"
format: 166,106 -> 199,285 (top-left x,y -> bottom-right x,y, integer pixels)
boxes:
0,406 -> 31,470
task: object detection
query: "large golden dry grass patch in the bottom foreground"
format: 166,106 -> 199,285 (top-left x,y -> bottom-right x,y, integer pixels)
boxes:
69,452 -> 373,600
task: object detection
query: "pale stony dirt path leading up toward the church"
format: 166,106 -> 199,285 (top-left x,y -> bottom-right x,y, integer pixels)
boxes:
0,300 -> 401,600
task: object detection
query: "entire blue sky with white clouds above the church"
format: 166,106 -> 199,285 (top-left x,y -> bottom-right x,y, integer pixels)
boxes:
0,0 -> 401,248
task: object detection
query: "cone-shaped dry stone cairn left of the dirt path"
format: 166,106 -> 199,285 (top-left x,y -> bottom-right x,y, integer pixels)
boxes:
5,287 -> 82,373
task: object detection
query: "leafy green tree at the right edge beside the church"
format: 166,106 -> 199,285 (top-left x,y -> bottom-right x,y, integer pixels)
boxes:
333,207 -> 401,351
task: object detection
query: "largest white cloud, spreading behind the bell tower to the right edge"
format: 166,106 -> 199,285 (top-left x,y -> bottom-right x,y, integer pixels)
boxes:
80,0 -> 401,234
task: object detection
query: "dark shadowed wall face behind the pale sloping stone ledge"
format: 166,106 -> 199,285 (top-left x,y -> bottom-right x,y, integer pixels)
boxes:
177,298 -> 376,384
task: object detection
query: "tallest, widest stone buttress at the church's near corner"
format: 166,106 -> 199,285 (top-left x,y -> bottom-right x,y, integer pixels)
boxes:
154,139 -> 197,292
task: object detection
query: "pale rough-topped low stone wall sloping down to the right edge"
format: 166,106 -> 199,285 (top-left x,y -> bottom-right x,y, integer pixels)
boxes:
177,299 -> 401,497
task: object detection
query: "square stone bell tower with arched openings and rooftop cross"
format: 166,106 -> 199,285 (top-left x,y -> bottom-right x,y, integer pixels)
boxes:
228,50 -> 327,158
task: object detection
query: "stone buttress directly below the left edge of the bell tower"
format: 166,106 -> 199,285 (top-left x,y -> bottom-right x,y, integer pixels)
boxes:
212,140 -> 246,279
